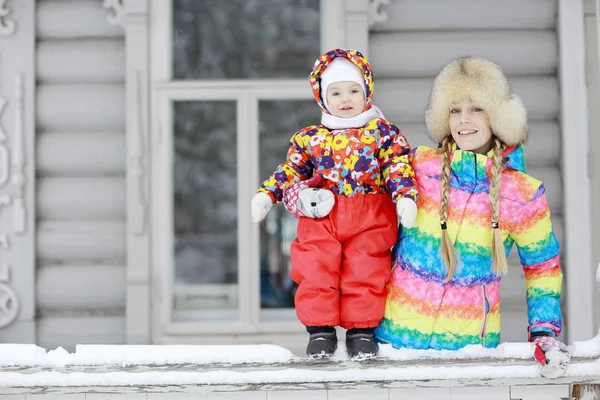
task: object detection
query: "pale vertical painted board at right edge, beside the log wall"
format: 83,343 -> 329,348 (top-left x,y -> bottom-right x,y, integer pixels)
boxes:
558,0 -> 595,341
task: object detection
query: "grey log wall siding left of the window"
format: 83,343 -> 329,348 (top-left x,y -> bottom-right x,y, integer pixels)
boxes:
36,0 -> 126,350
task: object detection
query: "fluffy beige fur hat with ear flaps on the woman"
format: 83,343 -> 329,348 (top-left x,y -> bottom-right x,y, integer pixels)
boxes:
425,57 -> 528,146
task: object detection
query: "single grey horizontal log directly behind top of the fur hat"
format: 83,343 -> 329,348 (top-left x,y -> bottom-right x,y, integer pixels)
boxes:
369,30 -> 558,79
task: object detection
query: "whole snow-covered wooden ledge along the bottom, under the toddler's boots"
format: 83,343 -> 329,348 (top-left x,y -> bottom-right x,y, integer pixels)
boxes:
0,335 -> 600,400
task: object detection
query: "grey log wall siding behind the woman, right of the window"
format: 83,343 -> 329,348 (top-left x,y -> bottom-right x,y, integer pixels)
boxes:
369,0 -> 568,341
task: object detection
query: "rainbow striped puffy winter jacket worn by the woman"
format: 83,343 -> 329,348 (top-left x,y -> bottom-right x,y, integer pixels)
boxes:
375,146 -> 562,350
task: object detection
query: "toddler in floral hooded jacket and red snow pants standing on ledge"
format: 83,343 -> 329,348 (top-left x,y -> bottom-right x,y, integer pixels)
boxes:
252,49 -> 417,358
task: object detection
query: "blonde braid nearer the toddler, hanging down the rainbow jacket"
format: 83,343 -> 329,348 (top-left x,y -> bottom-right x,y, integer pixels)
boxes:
440,136 -> 456,282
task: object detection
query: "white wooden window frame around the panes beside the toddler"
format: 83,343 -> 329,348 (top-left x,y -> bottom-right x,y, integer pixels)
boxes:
150,0 -> 358,343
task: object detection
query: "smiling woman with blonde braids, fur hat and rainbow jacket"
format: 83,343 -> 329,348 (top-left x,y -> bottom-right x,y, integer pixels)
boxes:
375,57 -> 569,376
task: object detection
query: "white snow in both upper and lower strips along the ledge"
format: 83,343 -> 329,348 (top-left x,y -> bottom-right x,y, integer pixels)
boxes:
0,332 -> 600,387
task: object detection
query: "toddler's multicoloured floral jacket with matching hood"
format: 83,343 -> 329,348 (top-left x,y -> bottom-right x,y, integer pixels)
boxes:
258,49 -> 418,203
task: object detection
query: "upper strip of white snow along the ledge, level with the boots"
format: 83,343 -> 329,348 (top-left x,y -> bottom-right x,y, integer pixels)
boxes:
0,331 -> 600,367
